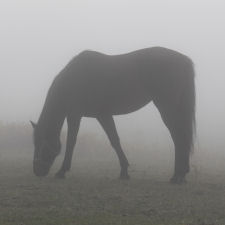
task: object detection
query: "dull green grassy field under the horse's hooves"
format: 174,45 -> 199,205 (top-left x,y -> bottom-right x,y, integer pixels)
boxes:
0,153 -> 225,225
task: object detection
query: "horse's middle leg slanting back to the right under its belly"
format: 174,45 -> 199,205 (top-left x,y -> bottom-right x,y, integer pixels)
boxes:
97,115 -> 129,179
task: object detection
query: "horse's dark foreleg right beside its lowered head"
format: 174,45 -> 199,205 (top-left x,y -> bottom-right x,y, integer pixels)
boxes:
55,115 -> 81,178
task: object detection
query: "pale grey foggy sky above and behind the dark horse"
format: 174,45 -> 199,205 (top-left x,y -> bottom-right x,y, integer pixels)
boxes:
0,0 -> 225,149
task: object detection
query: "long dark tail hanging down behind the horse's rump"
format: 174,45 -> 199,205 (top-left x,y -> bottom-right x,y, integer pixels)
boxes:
179,61 -> 196,152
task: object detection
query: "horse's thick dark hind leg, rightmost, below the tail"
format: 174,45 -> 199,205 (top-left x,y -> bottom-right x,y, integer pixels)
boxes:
154,102 -> 190,183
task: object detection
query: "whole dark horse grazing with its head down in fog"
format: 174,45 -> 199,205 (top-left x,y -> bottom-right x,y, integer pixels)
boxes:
31,47 -> 195,183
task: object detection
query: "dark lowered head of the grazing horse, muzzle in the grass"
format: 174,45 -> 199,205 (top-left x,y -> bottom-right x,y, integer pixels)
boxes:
31,122 -> 61,176
